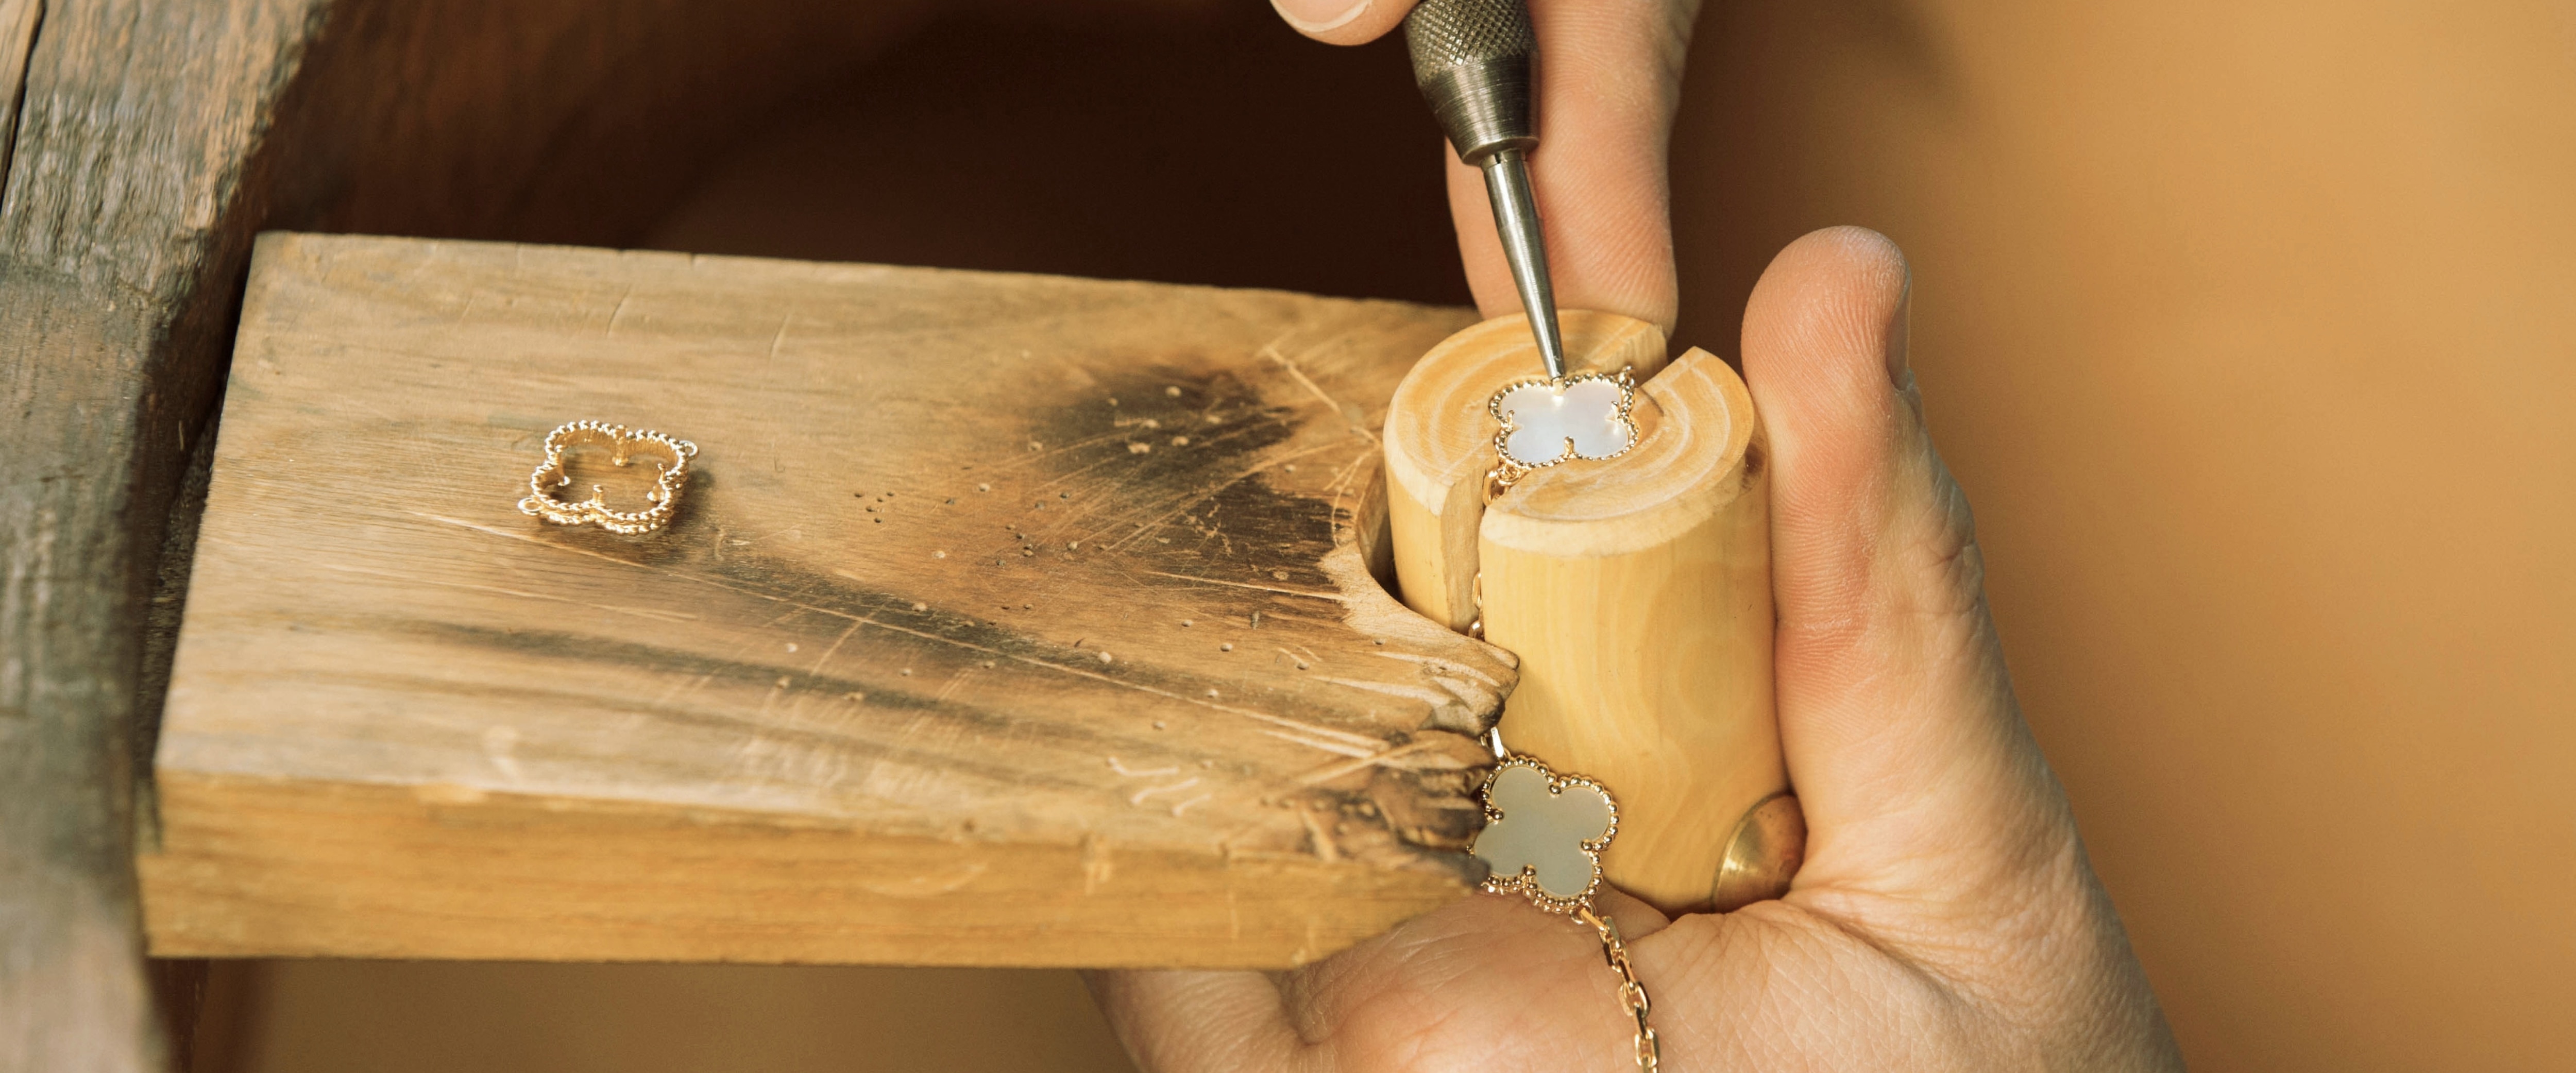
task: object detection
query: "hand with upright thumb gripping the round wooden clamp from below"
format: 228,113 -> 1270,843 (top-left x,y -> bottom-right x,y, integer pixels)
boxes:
1092,221 -> 2182,1073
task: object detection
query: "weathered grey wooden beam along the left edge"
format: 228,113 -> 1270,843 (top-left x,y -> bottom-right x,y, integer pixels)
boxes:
0,3 -> 319,1070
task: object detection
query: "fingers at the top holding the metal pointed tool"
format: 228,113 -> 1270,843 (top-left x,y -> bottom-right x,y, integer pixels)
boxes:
1270,0 -> 1700,332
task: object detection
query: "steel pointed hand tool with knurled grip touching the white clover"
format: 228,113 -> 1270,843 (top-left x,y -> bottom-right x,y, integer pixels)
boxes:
1404,0 -> 1566,381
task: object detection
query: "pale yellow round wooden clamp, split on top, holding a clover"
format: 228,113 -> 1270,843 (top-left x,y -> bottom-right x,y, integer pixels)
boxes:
1386,314 -> 1795,911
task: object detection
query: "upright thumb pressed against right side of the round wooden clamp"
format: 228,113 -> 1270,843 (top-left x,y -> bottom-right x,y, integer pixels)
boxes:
1744,227 -> 2074,900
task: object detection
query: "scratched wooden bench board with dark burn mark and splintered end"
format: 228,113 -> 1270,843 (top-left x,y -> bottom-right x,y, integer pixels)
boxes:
142,234 -> 1512,965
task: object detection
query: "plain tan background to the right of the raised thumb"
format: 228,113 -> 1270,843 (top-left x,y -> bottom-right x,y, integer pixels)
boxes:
1677,0 -> 2576,1070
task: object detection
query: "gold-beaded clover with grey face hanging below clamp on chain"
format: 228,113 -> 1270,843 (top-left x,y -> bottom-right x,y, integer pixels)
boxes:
1468,754 -> 1618,913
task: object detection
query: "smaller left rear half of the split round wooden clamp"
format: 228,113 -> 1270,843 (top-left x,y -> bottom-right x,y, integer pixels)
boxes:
1386,309 -> 1667,631
